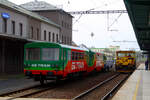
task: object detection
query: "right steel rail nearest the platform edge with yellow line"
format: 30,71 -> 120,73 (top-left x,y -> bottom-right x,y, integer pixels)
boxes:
101,74 -> 129,100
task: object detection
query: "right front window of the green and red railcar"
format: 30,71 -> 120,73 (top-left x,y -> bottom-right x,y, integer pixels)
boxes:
42,48 -> 59,61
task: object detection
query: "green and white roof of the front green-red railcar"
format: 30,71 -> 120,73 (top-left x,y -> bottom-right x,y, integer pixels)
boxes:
25,41 -> 90,51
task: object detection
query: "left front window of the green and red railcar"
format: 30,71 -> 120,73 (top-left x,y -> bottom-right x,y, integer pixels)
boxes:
26,48 -> 40,60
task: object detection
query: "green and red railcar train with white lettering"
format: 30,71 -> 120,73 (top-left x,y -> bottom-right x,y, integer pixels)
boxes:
24,42 -> 113,84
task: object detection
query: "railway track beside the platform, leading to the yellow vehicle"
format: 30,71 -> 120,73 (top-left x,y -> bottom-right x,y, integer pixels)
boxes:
72,73 -> 129,100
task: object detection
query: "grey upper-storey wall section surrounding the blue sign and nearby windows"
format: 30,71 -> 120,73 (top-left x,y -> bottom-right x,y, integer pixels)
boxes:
0,7 -> 28,38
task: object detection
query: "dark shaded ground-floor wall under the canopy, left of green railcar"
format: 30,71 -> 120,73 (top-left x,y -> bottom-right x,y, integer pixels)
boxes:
0,37 -> 26,74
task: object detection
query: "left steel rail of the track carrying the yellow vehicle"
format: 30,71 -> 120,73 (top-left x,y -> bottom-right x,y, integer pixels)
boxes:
71,73 -> 120,100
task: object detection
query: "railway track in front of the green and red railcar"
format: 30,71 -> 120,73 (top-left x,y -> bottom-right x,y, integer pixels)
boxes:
0,82 -> 56,99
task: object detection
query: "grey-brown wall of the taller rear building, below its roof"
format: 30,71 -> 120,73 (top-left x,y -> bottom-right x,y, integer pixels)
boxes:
36,10 -> 72,45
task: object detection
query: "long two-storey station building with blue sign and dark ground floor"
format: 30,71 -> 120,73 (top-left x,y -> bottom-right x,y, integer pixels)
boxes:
0,0 -> 61,74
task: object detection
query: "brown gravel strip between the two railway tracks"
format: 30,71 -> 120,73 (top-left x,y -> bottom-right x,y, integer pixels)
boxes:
26,72 -> 116,99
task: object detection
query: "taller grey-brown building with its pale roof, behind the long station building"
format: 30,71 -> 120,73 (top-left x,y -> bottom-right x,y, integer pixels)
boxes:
20,0 -> 72,45
